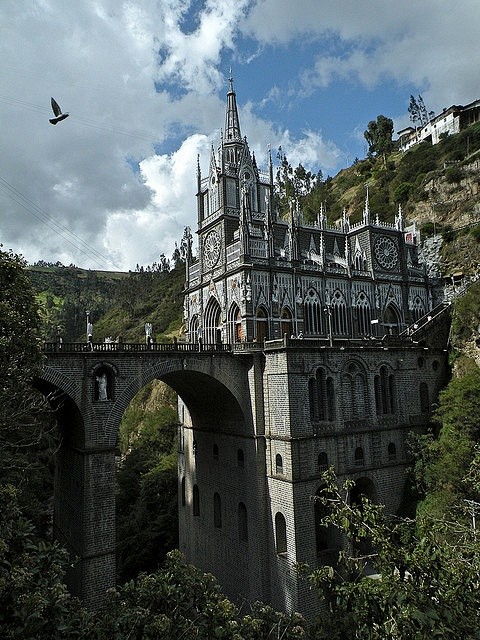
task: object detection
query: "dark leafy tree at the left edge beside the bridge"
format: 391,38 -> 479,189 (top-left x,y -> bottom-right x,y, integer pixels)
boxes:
0,250 -> 55,521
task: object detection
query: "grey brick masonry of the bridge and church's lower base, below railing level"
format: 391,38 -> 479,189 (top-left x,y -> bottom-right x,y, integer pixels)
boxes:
44,341 -> 445,613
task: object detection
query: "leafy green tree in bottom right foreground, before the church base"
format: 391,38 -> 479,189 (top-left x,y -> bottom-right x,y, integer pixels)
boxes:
310,470 -> 480,640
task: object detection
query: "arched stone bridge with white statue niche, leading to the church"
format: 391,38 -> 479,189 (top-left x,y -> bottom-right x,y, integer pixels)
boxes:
36,343 -> 263,606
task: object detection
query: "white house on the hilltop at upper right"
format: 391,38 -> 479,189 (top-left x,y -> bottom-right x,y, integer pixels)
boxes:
398,100 -> 480,151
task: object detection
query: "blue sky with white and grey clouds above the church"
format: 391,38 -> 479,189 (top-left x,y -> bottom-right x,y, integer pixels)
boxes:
0,0 -> 480,270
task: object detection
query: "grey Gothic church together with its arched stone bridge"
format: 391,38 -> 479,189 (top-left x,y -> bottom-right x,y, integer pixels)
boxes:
37,77 -> 448,613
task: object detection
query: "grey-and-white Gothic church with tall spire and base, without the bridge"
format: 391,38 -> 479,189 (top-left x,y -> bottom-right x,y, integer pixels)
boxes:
179,76 -> 448,613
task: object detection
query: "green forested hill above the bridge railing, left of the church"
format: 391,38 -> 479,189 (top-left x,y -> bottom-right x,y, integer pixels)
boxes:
28,260 -> 185,342
